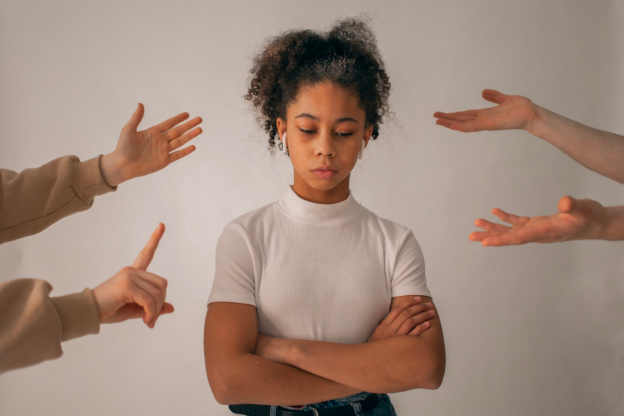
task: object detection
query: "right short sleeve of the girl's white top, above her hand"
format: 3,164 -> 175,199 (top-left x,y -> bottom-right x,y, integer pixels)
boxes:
391,230 -> 431,297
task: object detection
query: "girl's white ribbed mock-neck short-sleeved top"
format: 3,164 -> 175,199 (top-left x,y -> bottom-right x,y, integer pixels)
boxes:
208,187 -> 431,344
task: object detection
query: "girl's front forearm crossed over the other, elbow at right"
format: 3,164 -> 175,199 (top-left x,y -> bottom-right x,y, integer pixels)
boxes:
252,296 -> 446,393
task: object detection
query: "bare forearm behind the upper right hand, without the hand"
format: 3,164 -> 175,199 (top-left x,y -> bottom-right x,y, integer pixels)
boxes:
528,105 -> 624,183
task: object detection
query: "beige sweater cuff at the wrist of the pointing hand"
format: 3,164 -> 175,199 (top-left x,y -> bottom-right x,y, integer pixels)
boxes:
50,289 -> 100,341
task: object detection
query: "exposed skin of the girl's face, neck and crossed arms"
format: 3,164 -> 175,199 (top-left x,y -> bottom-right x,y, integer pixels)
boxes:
204,82 -> 445,405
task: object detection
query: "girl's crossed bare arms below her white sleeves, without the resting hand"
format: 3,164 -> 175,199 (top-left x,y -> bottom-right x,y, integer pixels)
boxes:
204,296 -> 446,406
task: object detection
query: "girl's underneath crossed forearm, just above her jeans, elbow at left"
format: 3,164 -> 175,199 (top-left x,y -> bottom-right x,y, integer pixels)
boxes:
208,354 -> 362,406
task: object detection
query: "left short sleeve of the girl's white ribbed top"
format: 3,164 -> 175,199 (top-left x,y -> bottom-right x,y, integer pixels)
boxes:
208,224 -> 256,306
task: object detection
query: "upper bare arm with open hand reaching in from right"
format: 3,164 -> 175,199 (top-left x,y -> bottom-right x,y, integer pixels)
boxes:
433,89 -> 624,183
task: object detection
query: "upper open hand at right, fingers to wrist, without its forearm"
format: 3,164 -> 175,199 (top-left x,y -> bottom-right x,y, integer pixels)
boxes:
433,90 -> 538,133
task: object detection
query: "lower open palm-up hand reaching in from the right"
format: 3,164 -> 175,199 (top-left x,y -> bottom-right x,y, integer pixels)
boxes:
469,196 -> 606,247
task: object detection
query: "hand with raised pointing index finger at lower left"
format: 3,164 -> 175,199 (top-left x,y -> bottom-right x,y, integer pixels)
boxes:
93,223 -> 173,328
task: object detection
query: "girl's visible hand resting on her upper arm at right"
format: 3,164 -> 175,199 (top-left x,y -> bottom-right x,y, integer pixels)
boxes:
367,296 -> 435,342
